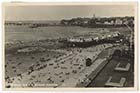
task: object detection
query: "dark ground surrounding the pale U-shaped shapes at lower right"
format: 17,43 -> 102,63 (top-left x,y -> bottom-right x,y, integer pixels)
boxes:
87,54 -> 134,87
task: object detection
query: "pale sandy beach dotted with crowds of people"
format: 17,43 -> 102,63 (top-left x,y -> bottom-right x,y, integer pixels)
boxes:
6,41 -> 117,85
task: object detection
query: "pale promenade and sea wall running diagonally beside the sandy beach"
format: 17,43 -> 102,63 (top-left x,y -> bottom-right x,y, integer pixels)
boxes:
59,49 -> 115,87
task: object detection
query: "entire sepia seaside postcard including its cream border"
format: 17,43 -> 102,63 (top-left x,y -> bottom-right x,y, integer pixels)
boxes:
2,2 -> 138,90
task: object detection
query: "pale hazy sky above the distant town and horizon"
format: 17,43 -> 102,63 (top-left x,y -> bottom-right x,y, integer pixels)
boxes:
4,5 -> 134,20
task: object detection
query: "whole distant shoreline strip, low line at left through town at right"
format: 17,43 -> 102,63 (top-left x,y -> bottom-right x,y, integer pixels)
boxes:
5,15 -> 134,28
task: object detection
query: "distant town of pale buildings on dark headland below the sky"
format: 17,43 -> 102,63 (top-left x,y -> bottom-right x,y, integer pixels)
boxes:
61,15 -> 134,27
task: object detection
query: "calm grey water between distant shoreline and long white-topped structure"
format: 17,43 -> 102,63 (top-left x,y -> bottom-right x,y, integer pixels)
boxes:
5,26 -> 127,42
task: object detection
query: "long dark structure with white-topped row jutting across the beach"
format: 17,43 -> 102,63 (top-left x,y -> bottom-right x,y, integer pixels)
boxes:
61,31 -> 123,47
